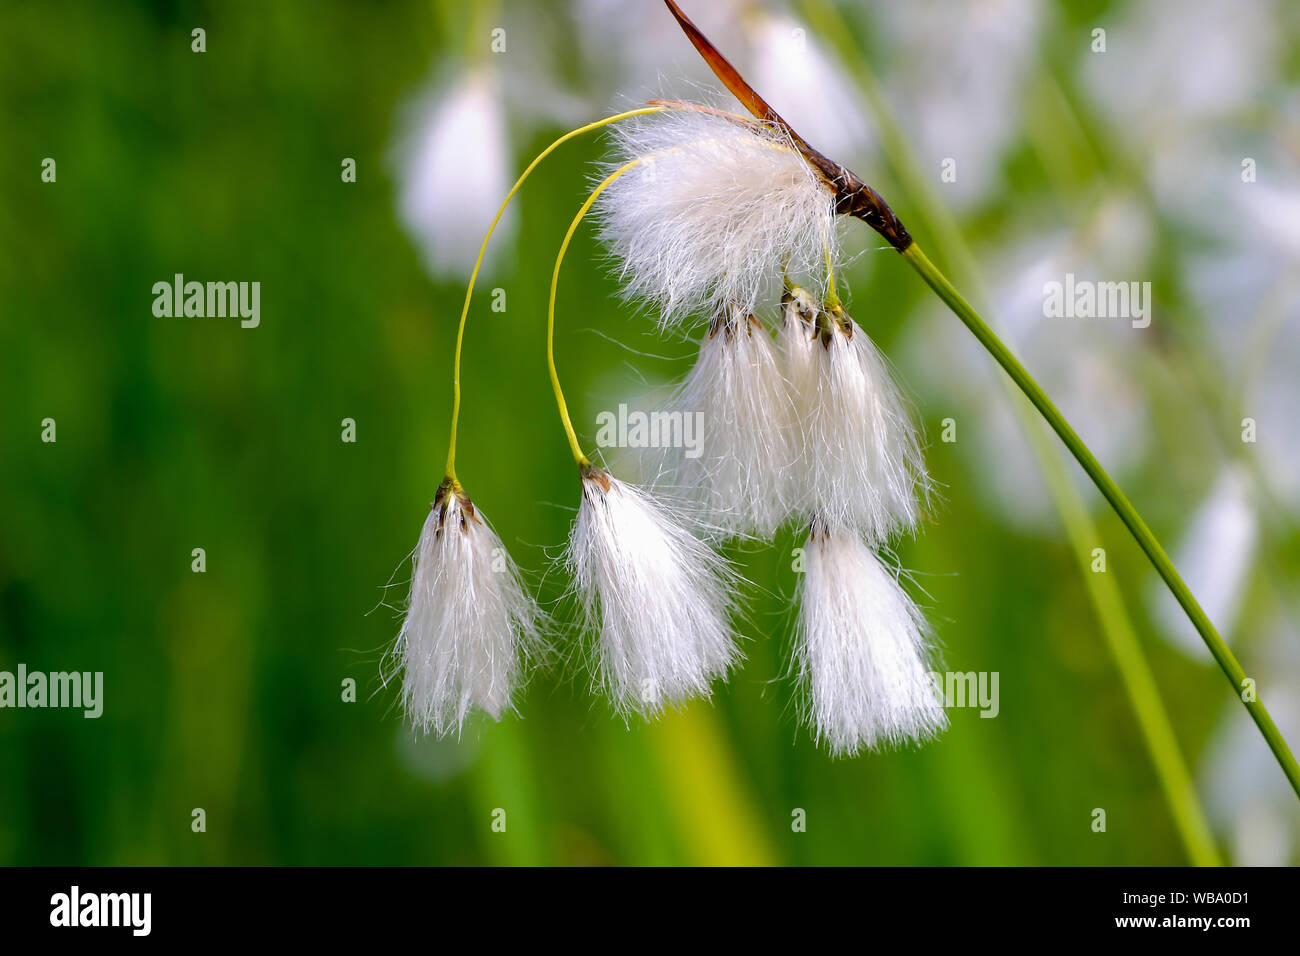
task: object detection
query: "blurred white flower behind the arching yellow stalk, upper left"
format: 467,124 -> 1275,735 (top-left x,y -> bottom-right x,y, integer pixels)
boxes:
397,68 -> 514,278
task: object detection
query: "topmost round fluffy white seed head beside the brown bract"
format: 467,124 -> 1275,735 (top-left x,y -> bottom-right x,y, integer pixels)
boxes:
597,111 -> 839,326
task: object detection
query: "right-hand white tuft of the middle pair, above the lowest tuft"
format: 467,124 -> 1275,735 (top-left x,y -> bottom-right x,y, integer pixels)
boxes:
781,290 -> 930,544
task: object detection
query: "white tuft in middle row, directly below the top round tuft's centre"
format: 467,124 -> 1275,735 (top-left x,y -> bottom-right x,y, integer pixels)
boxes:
660,307 -> 797,537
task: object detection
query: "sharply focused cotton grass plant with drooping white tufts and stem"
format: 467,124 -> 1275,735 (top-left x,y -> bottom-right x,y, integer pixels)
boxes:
384,0 -> 1300,793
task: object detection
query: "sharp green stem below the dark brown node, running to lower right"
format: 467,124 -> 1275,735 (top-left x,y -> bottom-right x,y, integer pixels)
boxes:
902,243 -> 1300,796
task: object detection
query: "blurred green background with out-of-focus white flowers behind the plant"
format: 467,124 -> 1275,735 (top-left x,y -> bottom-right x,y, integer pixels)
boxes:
0,0 -> 1300,865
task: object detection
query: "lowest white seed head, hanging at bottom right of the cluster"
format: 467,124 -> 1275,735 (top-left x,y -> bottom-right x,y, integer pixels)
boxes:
797,522 -> 948,754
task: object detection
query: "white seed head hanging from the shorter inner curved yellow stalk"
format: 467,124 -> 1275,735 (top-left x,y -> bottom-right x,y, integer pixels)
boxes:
568,467 -> 738,715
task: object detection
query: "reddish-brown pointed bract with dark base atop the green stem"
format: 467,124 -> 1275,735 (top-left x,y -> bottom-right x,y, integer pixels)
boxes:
663,0 -> 911,252
